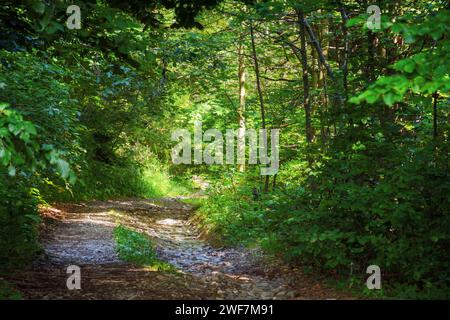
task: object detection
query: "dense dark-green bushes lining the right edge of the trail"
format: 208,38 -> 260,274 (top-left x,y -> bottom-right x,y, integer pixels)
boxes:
200,145 -> 450,298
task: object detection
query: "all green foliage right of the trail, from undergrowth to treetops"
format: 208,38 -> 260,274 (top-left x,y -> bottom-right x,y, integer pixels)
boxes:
170,1 -> 450,298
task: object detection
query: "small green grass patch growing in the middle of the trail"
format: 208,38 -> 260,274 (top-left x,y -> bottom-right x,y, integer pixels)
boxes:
114,225 -> 178,273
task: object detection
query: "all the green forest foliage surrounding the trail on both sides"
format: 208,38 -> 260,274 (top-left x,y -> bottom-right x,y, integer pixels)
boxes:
0,0 -> 450,298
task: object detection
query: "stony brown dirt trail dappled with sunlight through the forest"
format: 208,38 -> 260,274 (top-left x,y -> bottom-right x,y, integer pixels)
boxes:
10,198 -> 352,299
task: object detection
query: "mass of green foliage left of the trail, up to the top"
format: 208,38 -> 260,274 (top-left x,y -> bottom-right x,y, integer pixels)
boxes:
0,1 -> 191,278
